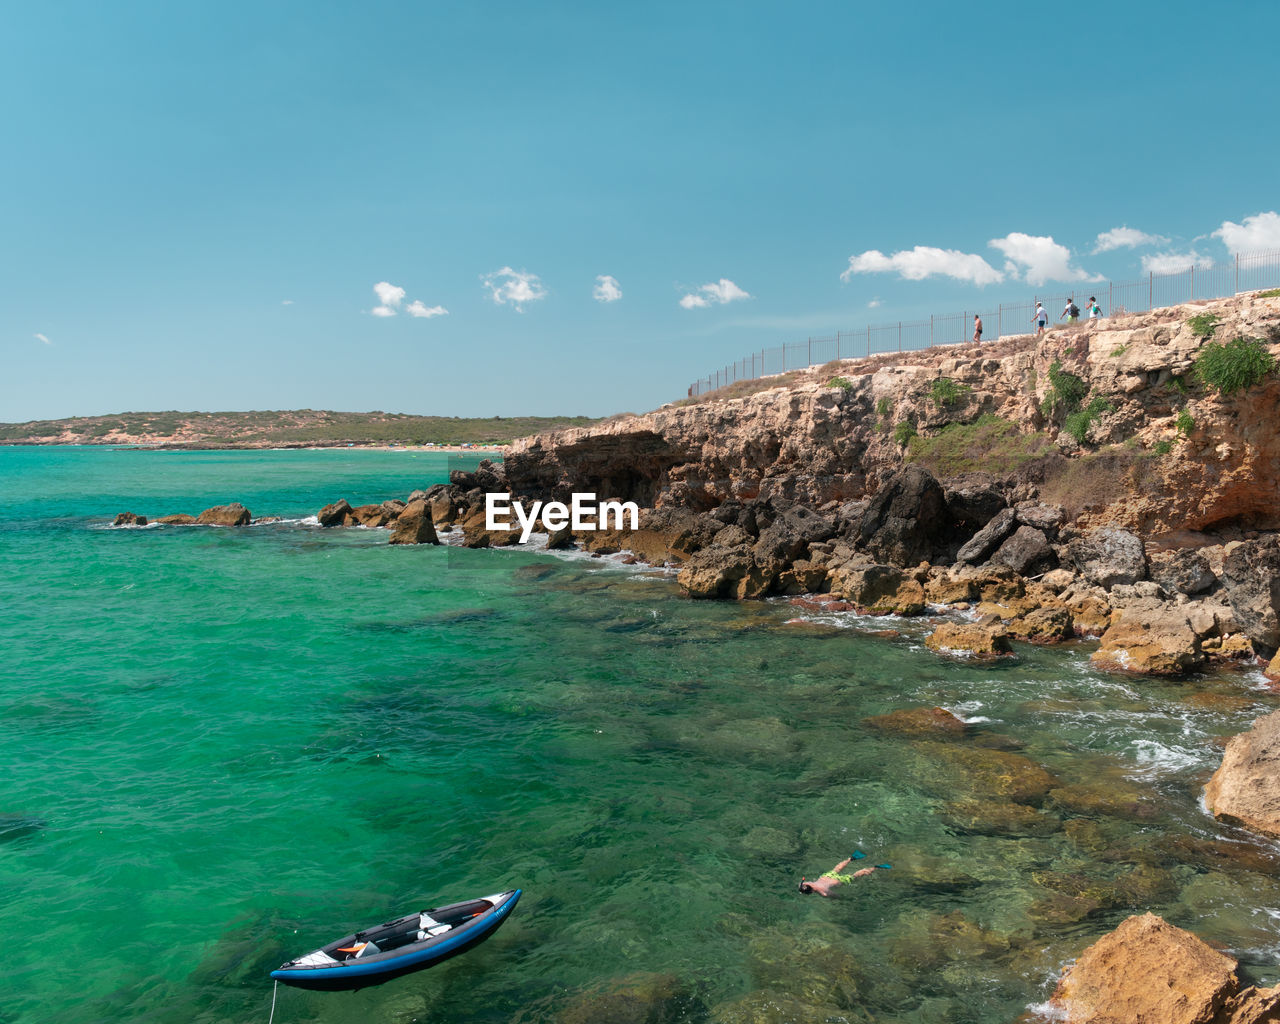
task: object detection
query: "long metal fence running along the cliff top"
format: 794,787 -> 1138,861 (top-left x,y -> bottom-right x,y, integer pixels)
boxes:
689,250 -> 1280,397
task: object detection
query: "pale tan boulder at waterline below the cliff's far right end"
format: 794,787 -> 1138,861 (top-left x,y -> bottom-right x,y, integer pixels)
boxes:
1089,598 -> 1212,677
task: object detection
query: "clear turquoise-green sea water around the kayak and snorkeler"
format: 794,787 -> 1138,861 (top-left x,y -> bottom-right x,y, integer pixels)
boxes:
0,448 -> 1280,1024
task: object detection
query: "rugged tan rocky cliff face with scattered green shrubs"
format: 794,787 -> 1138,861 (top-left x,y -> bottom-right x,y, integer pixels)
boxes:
506,294 -> 1280,536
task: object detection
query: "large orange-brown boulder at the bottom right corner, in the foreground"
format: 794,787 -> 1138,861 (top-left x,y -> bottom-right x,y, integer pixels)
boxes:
1050,914 -> 1239,1024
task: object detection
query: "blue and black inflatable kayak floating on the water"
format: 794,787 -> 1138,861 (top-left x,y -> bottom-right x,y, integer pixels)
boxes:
271,888 -> 522,992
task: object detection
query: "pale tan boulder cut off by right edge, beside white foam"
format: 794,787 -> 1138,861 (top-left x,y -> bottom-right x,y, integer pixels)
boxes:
1204,712 -> 1280,836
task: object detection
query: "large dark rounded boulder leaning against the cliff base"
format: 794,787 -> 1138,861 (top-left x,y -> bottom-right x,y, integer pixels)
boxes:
855,466 -> 954,567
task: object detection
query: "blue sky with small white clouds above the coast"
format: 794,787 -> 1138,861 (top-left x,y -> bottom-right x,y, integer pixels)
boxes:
0,0 -> 1280,422
